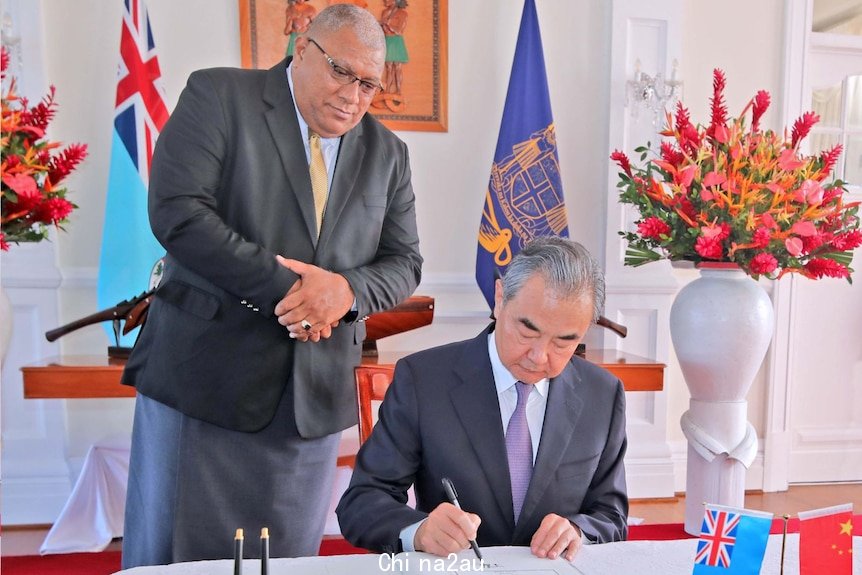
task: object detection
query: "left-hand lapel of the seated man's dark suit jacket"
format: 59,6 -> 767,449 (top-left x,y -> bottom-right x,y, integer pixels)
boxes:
449,330 -> 514,531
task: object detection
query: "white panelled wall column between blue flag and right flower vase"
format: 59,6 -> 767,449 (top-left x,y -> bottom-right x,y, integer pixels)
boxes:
602,0 -> 683,498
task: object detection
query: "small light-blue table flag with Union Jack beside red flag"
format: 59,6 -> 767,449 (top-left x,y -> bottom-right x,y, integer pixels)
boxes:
692,504 -> 772,575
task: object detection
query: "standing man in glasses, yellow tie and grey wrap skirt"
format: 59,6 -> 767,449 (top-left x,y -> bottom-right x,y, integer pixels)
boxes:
123,4 -> 422,568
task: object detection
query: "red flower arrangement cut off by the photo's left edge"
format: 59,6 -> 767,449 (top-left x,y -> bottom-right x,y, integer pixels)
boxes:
0,50 -> 87,251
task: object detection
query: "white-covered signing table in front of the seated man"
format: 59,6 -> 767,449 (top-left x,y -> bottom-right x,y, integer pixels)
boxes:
119,534 -> 862,575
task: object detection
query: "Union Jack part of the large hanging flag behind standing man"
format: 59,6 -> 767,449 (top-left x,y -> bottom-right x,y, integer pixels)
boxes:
114,0 -> 168,185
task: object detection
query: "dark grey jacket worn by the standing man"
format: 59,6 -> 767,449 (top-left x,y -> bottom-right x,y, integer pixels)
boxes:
123,61 -> 422,437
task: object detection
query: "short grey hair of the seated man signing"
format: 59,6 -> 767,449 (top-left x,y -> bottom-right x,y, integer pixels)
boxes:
502,236 -> 605,321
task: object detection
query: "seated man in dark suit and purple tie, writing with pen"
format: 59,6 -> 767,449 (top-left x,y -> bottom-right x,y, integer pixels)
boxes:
336,237 -> 628,560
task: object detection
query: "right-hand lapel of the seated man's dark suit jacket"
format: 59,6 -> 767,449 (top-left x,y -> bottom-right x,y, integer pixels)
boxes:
515,364 -> 584,538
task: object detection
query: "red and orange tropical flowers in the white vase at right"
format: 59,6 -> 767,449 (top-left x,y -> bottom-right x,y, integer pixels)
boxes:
611,69 -> 862,282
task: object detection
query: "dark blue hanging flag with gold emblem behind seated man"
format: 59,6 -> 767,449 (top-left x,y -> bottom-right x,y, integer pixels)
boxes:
476,0 -> 569,309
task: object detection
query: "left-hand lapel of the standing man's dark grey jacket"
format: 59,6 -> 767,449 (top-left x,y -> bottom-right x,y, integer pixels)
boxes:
263,60 -> 317,243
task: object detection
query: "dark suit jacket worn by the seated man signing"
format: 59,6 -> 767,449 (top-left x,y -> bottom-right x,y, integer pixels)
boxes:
336,328 -> 628,552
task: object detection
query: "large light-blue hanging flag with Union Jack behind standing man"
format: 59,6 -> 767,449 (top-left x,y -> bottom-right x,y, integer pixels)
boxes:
97,0 -> 168,345
